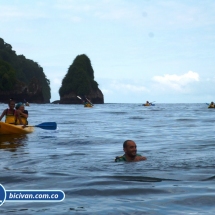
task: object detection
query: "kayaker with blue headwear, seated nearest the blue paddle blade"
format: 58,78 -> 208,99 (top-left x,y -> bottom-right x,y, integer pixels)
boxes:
15,102 -> 28,126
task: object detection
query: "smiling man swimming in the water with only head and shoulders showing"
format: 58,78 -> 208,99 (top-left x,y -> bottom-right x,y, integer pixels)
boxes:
115,140 -> 147,162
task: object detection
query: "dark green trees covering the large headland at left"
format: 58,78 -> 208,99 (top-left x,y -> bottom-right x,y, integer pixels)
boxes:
0,38 -> 51,102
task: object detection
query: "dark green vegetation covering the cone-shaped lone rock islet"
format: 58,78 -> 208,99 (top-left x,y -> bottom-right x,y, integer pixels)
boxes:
59,54 -> 98,97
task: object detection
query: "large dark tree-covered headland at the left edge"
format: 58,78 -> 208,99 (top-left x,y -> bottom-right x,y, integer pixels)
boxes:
0,38 -> 51,103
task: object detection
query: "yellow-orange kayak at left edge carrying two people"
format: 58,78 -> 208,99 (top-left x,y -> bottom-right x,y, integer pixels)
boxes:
0,122 -> 34,134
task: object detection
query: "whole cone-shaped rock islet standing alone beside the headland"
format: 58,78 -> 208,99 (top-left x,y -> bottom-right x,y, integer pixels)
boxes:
59,54 -> 104,104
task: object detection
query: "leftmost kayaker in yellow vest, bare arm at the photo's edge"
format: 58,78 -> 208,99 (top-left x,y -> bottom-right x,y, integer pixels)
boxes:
0,99 -> 16,124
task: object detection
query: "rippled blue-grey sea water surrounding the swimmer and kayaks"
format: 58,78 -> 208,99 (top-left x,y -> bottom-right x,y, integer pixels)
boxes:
0,103 -> 215,215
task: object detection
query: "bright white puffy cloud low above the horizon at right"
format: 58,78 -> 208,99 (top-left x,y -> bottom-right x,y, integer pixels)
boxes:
152,71 -> 199,92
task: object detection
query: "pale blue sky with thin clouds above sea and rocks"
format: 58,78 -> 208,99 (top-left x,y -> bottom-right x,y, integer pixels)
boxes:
0,0 -> 215,103
